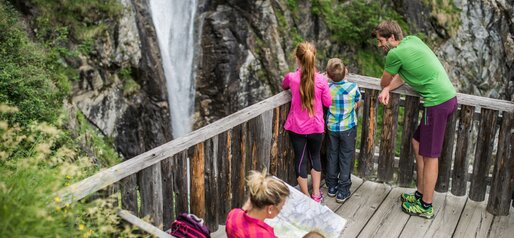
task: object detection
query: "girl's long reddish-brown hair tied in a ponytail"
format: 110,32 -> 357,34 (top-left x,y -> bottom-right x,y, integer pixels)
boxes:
296,42 -> 316,115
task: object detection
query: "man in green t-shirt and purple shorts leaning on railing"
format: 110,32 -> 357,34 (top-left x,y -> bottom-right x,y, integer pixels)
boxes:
372,21 -> 457,219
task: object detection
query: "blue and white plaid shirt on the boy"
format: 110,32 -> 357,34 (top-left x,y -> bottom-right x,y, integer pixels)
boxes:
327,80 -> 361,131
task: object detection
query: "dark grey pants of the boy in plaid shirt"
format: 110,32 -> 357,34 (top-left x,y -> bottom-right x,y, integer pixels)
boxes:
325,127 -> 357,195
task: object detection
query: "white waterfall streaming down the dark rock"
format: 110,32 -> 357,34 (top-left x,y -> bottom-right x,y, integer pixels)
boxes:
150,0 -> 197,138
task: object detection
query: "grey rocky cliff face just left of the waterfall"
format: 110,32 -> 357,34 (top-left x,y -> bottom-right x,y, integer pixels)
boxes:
72,0 -> 171,158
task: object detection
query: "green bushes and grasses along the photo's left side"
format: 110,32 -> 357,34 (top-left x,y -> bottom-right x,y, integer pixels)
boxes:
0,1 -> 133,237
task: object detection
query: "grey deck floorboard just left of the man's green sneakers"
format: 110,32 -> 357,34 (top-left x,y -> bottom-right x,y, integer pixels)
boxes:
359,188 -> 413,237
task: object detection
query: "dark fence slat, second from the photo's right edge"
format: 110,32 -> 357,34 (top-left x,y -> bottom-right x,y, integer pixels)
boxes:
469,109 -> 498,202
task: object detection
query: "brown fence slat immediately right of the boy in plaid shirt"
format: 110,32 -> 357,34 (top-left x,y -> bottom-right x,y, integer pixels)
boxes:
357,89 -> 379,178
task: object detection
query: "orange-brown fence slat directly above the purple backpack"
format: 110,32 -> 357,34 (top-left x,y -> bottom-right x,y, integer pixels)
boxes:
191,143 -> 206,218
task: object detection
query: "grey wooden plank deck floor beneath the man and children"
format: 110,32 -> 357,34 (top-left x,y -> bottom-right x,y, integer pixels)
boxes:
212,176 -> 514,238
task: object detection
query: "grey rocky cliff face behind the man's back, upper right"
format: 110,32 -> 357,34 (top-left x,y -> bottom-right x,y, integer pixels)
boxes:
437,0 -> 514,100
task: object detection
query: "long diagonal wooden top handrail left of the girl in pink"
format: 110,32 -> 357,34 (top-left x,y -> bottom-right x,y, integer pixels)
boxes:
56,91 -> 291,204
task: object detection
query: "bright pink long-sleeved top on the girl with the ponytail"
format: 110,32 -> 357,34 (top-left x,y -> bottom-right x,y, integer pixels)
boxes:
282,69 -> 332,135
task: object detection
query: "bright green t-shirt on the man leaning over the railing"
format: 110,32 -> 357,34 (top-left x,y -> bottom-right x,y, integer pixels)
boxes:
385,36 -> 457,107
